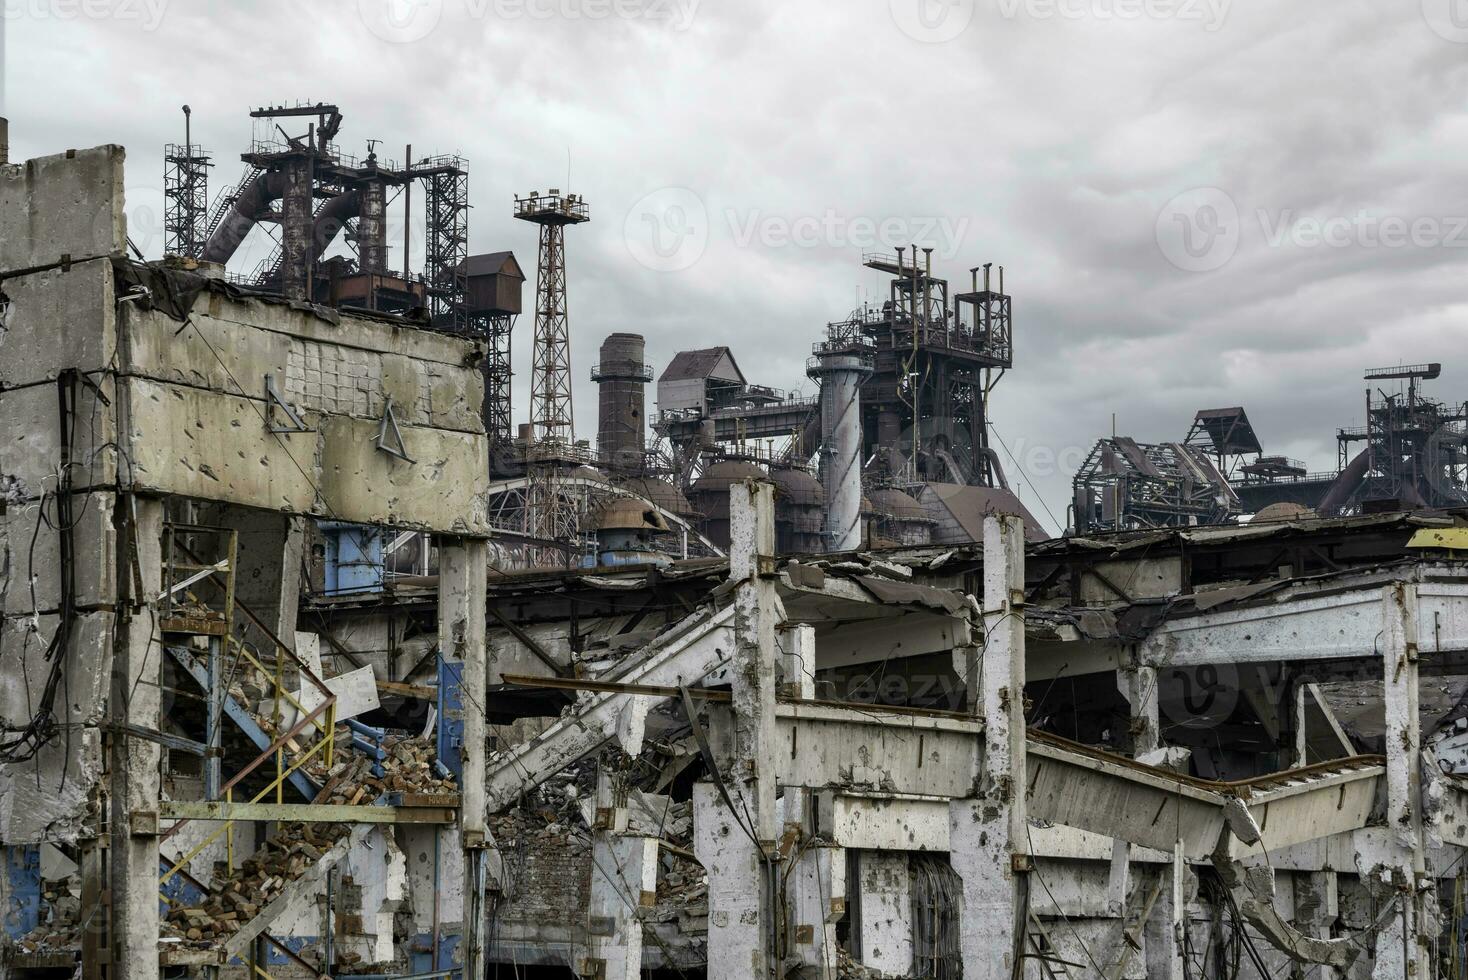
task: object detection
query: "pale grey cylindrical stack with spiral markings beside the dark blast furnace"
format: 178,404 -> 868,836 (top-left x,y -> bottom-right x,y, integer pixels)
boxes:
816,354 -> 872,552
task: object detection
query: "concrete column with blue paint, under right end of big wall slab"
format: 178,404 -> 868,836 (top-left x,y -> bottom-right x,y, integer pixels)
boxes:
439,540 -> 489,977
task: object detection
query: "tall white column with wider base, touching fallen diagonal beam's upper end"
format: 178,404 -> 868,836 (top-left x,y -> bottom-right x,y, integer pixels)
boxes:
694,480 -> 780,980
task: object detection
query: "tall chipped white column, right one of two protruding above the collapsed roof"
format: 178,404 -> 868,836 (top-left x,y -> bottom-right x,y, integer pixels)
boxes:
948,515 -> 1031,980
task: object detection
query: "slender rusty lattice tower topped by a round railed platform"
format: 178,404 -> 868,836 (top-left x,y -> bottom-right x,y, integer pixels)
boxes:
515,189 -> 590,557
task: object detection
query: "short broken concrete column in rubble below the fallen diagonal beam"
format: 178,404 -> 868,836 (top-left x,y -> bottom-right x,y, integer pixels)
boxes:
581,769 -> 658,980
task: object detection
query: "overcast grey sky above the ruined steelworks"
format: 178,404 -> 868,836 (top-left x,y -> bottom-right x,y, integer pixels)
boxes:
3,0 -> 1468,530
